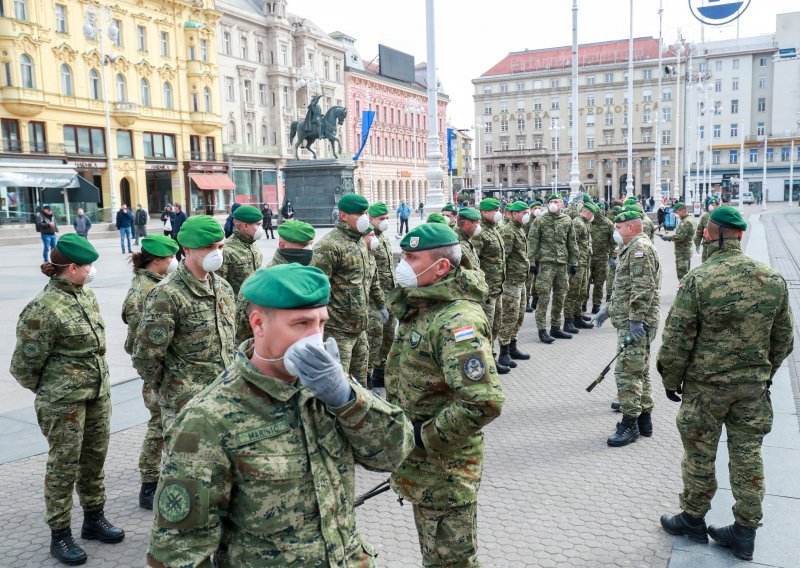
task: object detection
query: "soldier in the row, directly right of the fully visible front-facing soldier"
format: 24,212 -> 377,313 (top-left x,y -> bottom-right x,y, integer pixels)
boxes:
564,203 -> 599,333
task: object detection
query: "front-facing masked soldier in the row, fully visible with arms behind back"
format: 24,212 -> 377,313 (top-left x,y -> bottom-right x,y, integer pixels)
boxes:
528,193 -> 578,343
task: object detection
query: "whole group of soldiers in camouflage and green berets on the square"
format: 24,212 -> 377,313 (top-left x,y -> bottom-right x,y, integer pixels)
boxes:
11,193 -> 792,567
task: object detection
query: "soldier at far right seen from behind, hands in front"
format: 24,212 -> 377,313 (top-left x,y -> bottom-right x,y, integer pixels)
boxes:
657,206 -> 794,560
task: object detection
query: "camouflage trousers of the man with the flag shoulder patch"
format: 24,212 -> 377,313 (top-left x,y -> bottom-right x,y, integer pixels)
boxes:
414,503 -> 481,568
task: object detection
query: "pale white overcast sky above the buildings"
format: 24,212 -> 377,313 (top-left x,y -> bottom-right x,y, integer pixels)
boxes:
288,0 -> 800,128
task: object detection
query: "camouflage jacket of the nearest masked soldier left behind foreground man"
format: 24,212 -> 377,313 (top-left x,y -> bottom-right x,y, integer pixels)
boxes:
133,262 -> 235,410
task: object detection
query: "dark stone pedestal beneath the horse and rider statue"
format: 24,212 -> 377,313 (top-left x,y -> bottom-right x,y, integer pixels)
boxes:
281,159 -> 356,227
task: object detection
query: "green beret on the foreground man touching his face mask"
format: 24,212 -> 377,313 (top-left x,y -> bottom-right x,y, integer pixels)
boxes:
242,262 -> 331,310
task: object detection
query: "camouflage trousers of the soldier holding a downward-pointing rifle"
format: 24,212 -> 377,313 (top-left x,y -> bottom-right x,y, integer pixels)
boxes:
614,322 -> 653,418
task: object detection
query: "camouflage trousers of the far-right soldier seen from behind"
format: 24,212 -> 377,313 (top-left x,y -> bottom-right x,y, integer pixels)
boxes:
675,382 -> 772,527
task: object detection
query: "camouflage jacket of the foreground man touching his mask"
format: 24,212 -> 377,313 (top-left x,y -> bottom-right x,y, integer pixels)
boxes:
147,342 -> 414,568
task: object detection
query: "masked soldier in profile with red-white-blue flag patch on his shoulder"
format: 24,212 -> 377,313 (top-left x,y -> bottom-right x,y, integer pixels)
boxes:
386,223 -> 505,566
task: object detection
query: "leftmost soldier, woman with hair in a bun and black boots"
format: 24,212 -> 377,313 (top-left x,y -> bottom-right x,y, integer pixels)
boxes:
10,233 -> 125,566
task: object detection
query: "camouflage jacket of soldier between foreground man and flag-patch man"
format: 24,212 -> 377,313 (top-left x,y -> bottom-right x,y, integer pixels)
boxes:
311,220 -> 386,333
